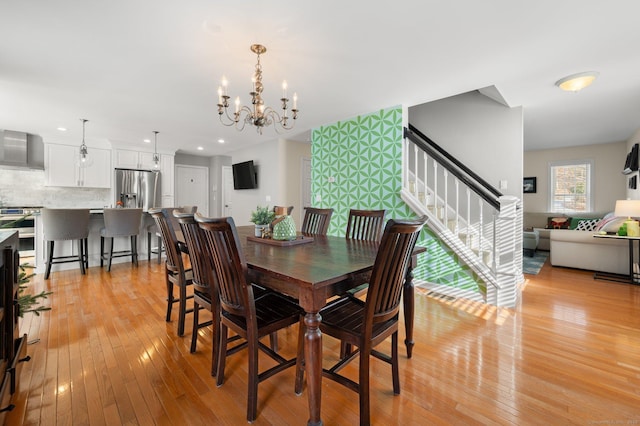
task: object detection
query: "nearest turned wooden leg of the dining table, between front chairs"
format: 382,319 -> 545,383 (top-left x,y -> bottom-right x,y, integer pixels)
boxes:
304,312 -> 322,426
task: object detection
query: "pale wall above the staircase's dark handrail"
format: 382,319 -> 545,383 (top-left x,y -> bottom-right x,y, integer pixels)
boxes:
409,92 -> 524,198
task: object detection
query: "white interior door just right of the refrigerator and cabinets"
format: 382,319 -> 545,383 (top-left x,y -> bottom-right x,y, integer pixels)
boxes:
175,164 -> 209,216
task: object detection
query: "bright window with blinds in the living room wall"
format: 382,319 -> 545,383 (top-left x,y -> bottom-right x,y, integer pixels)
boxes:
549,160 -> 593,213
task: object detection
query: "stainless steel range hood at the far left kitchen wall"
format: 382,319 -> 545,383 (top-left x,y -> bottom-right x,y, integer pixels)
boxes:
0,130 -> 44,170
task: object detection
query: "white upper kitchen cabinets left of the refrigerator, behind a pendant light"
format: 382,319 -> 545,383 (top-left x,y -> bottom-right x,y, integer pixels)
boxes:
45,144 -> 111,188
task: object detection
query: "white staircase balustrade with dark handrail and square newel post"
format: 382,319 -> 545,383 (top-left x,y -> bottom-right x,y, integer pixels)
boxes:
401,125 -> 524,307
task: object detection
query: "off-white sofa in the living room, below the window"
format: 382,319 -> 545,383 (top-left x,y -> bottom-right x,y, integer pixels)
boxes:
550,229 -> 629,275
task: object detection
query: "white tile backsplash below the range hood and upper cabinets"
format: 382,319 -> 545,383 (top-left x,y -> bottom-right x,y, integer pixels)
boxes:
0,168 -> 113,208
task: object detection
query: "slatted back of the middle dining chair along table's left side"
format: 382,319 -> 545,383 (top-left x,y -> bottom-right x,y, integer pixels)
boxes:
173,210 -> 212,295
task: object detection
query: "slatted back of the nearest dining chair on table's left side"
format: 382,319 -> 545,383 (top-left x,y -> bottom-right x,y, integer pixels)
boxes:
196,215 -> 255,324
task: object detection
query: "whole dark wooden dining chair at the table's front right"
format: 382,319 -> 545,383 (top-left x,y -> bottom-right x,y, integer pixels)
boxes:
296,216 -> 427,425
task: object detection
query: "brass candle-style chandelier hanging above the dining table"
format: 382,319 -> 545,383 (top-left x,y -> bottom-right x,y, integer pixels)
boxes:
218,44 -> 298,134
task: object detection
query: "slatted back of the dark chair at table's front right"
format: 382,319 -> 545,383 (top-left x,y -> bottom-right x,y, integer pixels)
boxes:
365,217 -> 427,332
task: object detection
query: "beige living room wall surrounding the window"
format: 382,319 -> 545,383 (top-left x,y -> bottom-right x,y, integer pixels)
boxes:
523,142 -> 624,213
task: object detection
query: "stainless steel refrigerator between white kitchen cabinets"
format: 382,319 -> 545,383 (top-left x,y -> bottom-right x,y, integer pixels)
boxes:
115,169 -> 160,212
